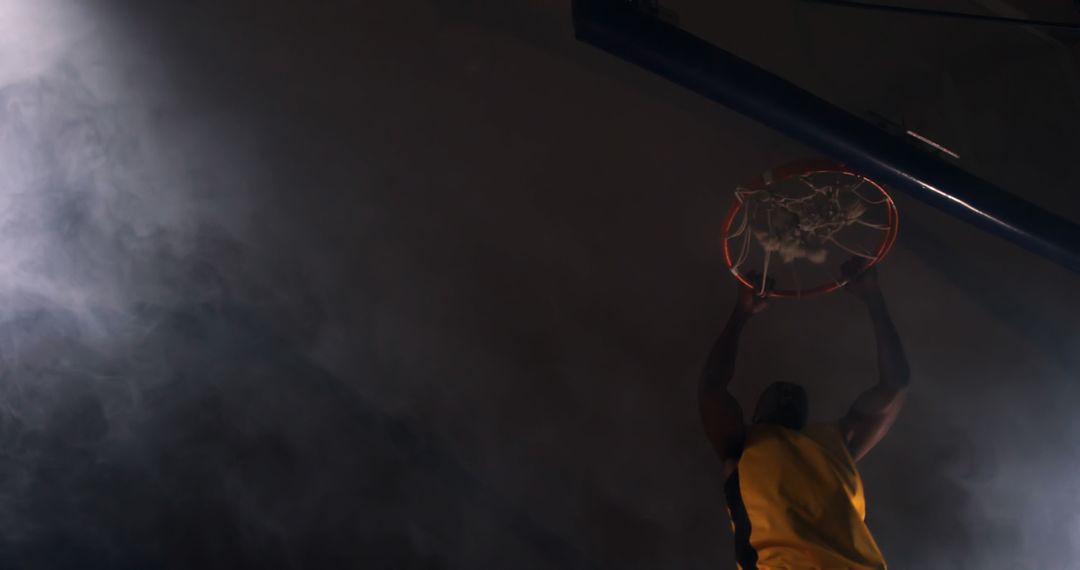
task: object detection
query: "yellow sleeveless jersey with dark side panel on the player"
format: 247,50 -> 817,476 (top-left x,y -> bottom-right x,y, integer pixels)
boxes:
724,424 -> 886,570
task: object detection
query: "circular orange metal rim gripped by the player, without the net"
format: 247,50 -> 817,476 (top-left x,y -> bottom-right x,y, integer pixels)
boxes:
721,159 -> 900,298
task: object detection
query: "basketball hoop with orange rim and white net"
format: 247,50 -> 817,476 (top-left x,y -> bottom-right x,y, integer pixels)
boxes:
723,159 -> 900,298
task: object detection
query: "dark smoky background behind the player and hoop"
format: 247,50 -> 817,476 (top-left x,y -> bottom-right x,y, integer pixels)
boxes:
0,0 -> 1080,570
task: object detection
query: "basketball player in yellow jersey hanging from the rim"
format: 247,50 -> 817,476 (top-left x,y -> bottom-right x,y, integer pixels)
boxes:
699,262 -> 909,570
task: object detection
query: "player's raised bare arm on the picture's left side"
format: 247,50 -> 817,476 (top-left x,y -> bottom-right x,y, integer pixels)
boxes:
698,285 -> 766,475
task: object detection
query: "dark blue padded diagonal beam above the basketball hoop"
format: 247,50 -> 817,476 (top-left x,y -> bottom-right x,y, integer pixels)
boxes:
572,0 -> 1080,272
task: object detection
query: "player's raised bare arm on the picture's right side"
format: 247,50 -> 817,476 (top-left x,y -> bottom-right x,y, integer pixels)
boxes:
840,261 -> 910,461
